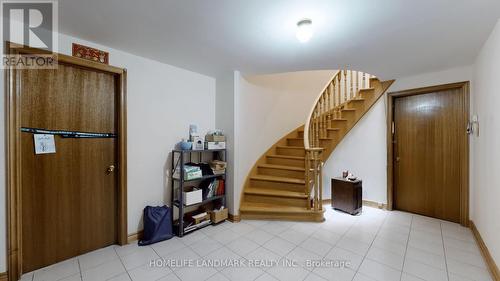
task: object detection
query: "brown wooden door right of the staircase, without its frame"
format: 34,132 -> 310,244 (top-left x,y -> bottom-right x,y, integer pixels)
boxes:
393,88 -> 468,222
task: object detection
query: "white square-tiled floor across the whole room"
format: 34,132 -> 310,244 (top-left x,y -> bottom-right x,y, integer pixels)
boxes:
21,206 -> 492,281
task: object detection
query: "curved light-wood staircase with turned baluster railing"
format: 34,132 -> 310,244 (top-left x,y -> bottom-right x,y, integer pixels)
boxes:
240,71 -> 394,222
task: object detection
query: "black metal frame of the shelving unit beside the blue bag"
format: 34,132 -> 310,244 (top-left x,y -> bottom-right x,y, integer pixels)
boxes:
170,149 -> 227,237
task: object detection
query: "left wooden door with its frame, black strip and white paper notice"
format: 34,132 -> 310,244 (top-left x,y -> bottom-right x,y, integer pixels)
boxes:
5,42 -> 127,280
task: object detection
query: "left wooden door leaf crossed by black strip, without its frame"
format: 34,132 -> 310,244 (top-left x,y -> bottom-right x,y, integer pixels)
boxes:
19,64 -> 118,272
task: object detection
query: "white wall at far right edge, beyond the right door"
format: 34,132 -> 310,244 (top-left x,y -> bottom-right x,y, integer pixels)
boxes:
472,21 -> 500,265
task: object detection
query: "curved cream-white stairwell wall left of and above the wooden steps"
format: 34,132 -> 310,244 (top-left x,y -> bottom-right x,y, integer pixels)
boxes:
234,70 -> 335,212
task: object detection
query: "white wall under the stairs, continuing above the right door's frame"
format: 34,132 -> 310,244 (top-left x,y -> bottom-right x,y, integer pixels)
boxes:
323,66 -> 472,204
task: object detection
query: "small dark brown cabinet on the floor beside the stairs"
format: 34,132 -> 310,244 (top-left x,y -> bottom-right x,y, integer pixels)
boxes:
331,178 -> 363,215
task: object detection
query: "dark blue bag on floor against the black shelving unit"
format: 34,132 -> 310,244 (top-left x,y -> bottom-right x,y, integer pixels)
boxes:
139,206 -> 173,246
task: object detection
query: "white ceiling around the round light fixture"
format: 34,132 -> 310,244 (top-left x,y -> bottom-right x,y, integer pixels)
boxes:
59,0 -> 500,78
